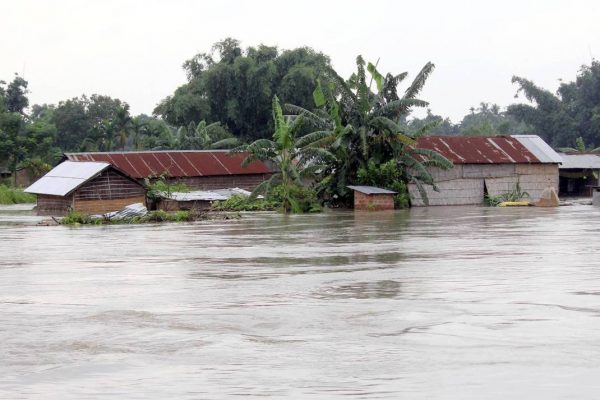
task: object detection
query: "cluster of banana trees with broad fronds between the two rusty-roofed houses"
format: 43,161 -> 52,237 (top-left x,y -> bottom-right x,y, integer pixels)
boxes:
289,56 -> 452,205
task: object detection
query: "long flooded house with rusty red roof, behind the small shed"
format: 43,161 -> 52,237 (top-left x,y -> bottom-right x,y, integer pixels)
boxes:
65,150 -> 273,190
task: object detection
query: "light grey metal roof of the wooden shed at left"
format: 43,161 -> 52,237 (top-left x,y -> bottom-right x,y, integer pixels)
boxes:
25,161 -> 110,196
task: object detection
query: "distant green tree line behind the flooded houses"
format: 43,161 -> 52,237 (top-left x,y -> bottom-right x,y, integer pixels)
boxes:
0,38 -> 600,183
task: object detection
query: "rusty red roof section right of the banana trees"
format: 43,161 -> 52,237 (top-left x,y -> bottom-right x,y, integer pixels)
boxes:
417,136 -> 542,164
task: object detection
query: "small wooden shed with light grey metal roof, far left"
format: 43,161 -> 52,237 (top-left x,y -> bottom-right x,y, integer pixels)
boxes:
25,161 -> 146,216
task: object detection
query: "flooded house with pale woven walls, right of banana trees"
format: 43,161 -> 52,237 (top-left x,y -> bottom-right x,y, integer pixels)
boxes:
408,135 -> 562,206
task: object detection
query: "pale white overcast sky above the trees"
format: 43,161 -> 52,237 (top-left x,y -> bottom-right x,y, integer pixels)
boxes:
0,0 -> 600,122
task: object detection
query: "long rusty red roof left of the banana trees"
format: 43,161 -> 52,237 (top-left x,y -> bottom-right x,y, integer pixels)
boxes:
65,150 -> 272,178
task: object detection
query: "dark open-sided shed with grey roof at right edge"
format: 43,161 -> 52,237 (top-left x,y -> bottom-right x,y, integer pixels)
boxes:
558,153 -> 600,197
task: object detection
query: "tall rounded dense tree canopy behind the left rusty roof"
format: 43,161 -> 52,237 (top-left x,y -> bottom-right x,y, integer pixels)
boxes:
154,38 -> 330,139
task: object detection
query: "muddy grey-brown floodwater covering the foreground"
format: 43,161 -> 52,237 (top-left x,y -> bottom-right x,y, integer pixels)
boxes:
0,205 -> 600,400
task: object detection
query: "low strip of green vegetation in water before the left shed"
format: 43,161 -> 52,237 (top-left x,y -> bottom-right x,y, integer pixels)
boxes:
59,210 -> 239,225
